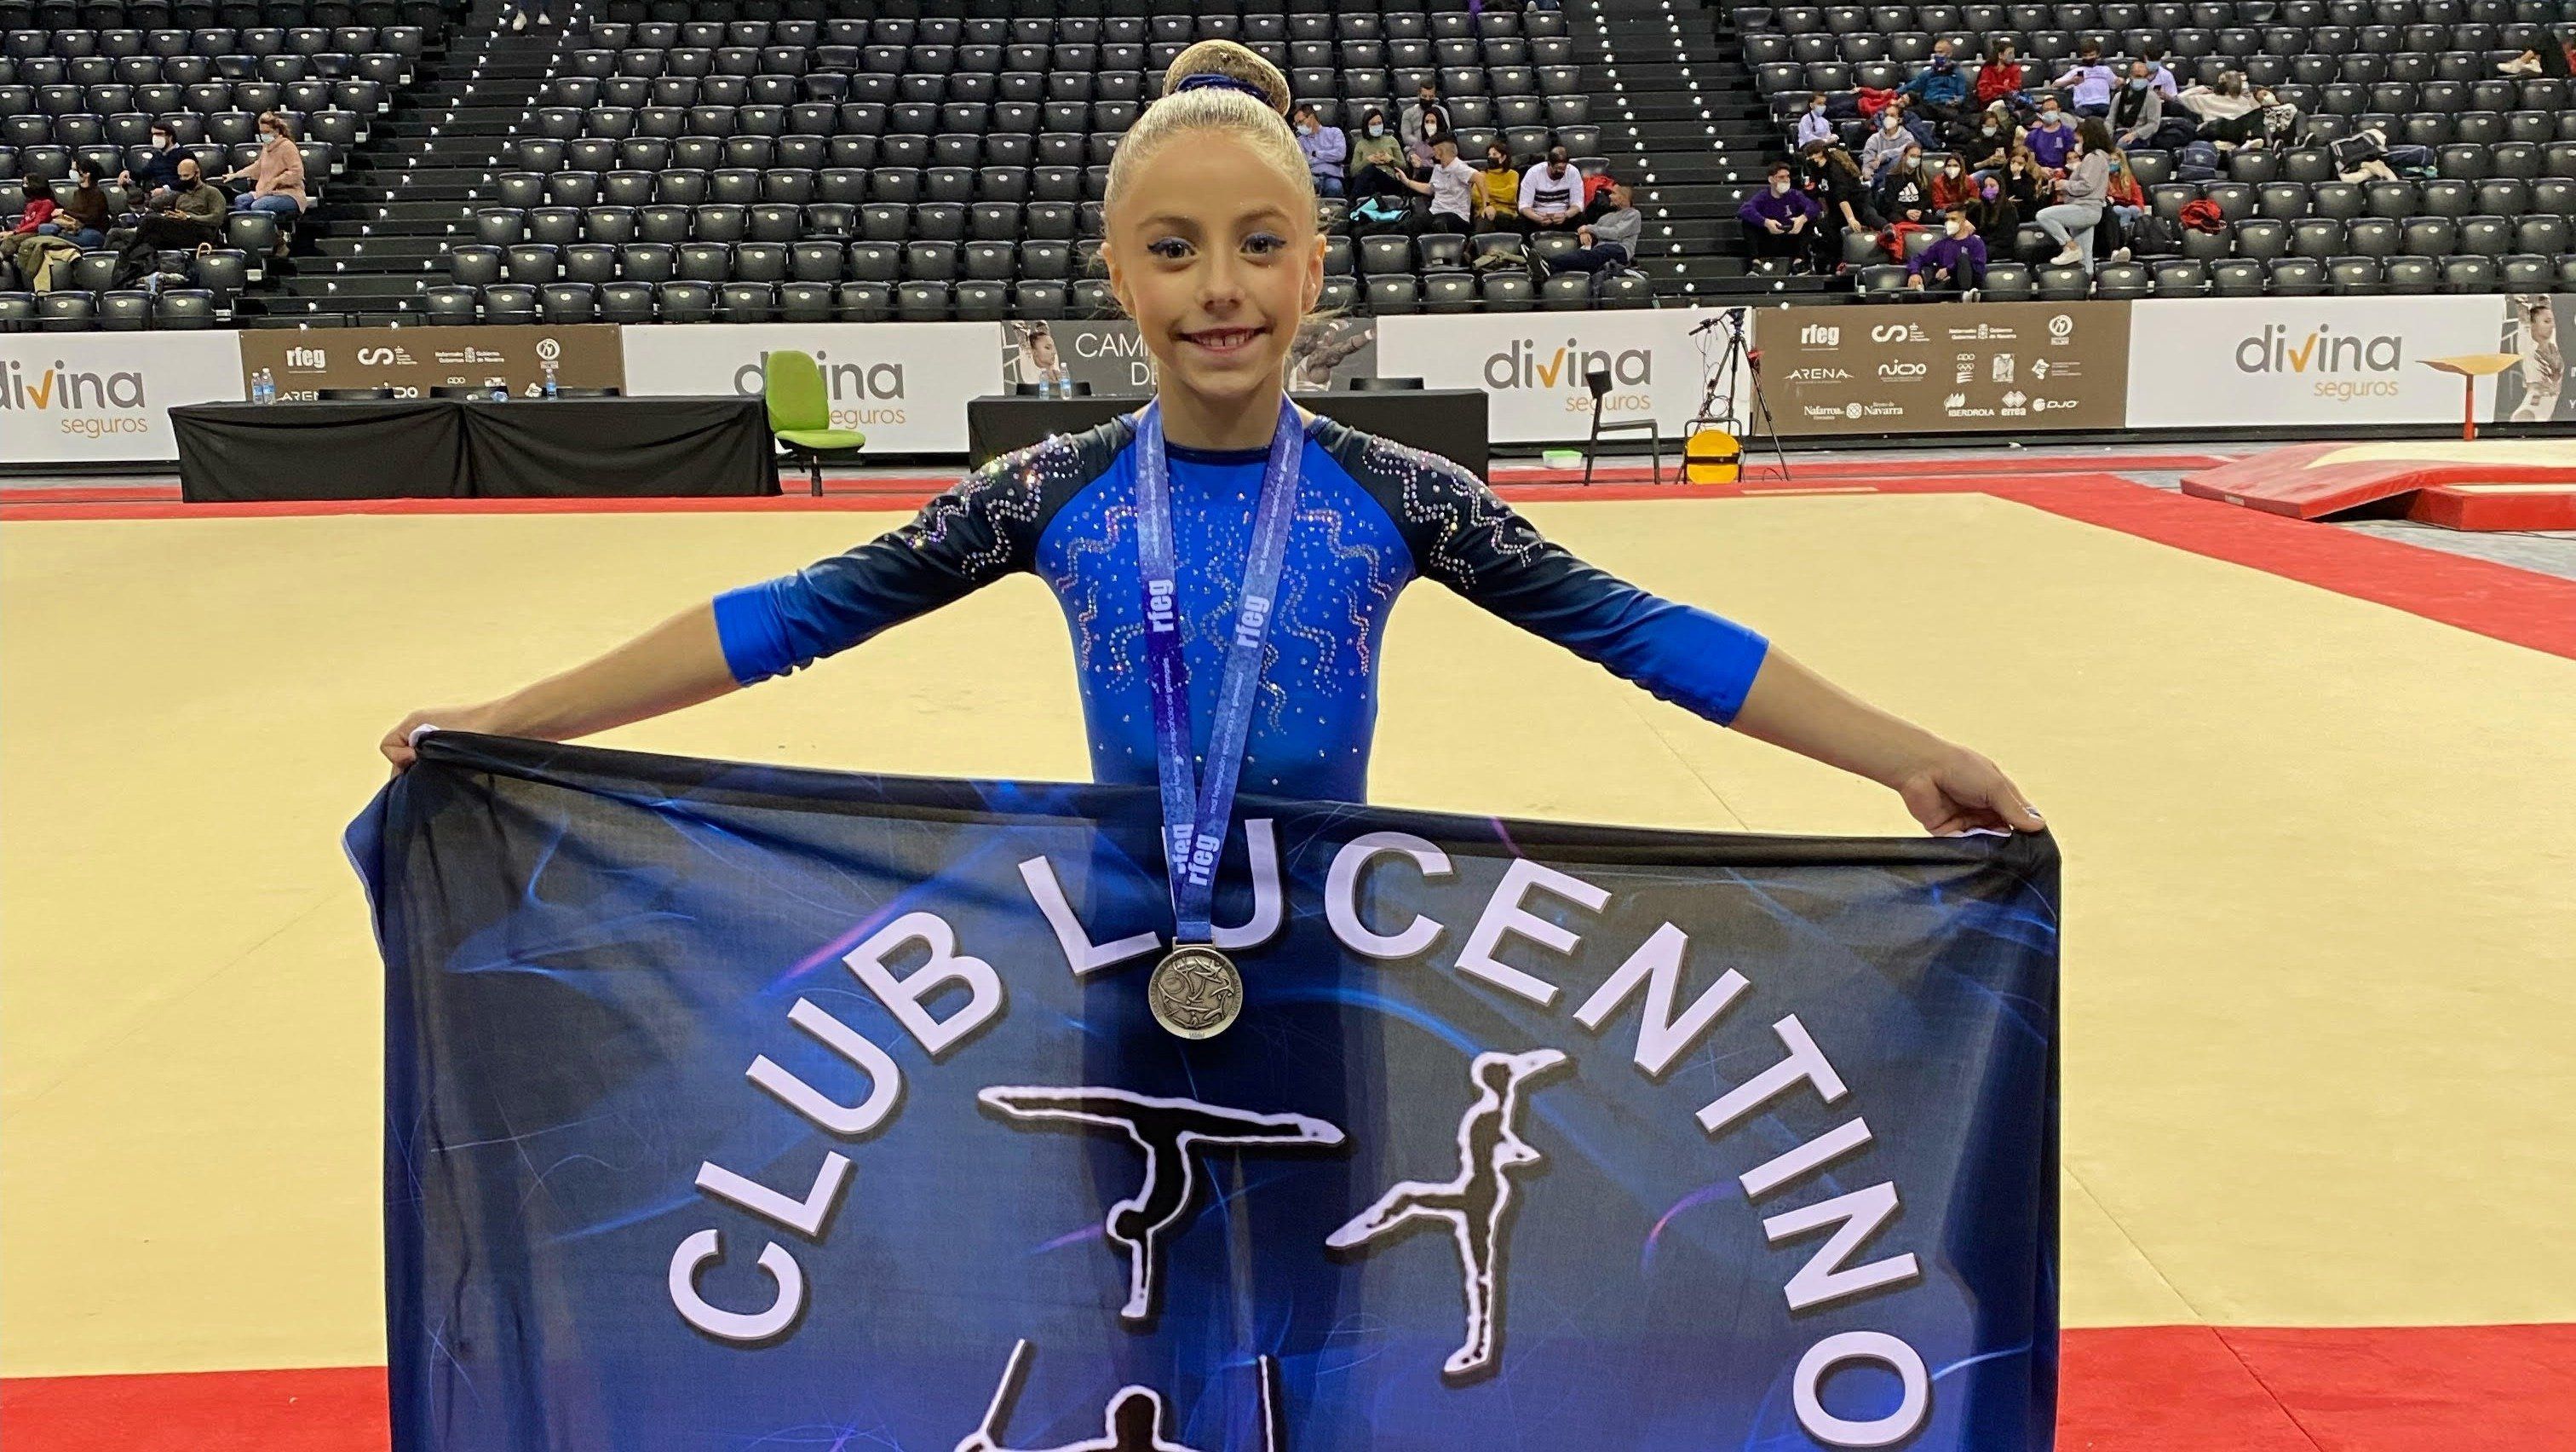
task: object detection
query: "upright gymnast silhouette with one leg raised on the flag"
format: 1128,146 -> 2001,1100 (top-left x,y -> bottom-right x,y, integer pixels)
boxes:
1324,1050 -> 1574,1385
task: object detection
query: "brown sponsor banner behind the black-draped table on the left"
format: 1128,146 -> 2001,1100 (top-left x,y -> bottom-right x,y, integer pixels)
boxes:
242,322 -> 626,400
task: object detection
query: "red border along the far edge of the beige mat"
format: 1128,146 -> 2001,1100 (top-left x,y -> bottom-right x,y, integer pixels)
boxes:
14,462 -> 2576,660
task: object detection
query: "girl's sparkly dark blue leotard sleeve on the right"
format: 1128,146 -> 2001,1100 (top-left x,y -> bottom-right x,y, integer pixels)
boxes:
1404,459 -> 1769,724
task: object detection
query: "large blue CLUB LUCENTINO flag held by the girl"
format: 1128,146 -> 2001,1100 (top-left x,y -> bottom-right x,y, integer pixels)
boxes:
350,735 -> 2058,1452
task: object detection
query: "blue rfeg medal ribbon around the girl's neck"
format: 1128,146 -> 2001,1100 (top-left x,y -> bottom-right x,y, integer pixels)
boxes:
1136,397 -> 1306,944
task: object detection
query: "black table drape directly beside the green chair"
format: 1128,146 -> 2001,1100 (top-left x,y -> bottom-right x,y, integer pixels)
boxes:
461,397 -> 778,498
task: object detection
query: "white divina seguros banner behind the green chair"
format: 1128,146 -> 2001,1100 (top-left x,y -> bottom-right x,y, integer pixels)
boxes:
626,322 -> 1002,454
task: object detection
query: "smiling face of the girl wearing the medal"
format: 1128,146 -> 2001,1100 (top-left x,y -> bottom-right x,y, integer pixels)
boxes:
1107,131 -> 1324,418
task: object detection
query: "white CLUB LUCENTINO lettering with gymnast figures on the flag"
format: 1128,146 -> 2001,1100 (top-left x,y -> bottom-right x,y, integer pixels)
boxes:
664,835 -> 1932,1452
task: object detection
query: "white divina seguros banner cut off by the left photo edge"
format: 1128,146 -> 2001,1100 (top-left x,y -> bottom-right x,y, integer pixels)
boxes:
0,330 -> 247,464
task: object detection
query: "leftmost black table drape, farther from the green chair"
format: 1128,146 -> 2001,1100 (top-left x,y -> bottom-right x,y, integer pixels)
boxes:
170,397 -> 471,503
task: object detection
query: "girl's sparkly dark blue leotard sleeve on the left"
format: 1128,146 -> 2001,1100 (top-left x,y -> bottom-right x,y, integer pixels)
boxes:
716,462 -> 1044,686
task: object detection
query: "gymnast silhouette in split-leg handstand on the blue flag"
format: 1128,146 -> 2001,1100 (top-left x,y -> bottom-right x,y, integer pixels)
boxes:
976,1083 -> 1343,1321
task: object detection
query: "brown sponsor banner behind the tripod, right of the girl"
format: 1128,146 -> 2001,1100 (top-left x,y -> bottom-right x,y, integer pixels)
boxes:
1754,302 -> 2128,436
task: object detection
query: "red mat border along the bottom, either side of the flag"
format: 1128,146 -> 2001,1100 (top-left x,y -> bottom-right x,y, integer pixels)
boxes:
0,1326 -> 2576,1452
